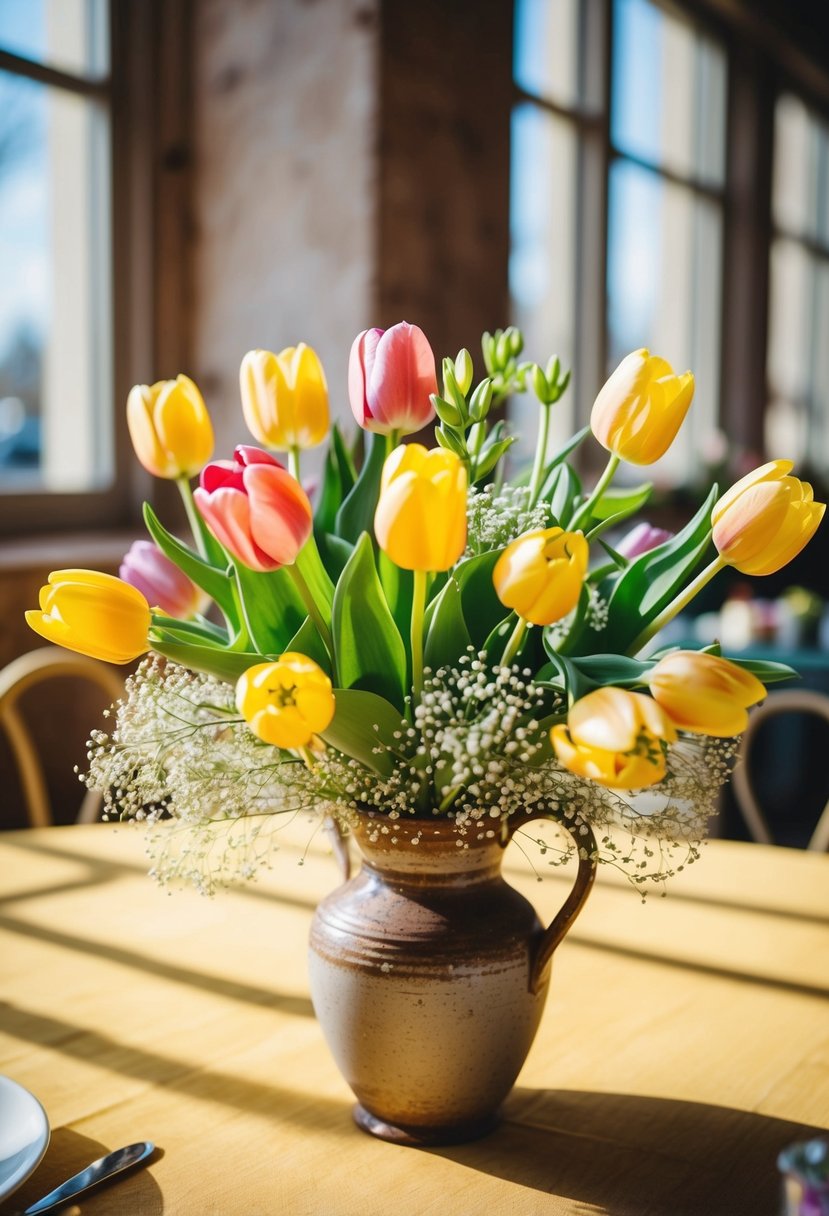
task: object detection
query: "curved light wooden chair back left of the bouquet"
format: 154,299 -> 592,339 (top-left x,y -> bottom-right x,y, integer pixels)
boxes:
0,646 -> 124,827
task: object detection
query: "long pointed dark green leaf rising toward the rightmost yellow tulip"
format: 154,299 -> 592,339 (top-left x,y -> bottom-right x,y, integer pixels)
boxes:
591,485 -> 718,654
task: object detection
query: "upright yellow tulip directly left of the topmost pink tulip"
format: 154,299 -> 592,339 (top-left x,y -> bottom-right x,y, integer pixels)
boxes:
239,342 -> 329,451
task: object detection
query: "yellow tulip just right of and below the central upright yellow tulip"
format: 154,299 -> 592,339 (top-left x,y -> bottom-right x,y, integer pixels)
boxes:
492,528 -> 588,625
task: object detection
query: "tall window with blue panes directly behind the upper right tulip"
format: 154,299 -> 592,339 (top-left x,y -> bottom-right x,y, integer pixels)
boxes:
511,0 -> 727,480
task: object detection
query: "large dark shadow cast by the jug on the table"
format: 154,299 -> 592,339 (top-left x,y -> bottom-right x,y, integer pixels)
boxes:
429,1088 -> 820,1216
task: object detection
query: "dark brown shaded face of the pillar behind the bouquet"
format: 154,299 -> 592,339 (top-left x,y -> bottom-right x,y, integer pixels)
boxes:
374,0 -> 513,368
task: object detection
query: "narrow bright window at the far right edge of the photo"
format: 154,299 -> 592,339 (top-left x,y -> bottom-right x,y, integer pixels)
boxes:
765,94 -> 829,475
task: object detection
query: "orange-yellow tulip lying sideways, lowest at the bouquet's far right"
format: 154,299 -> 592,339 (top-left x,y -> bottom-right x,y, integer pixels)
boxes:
648,651 -> 766,738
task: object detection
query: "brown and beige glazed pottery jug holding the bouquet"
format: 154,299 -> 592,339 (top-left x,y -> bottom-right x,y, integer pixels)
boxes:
310,816 -> 596,1144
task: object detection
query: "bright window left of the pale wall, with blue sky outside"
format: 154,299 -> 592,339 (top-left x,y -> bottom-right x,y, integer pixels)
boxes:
0,0 -> 114,513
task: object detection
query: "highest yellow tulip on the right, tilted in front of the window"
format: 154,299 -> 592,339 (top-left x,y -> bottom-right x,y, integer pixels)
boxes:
590,349 -> 694,465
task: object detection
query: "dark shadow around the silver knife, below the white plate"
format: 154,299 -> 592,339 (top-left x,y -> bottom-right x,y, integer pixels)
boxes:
0,1127 -> 164,1216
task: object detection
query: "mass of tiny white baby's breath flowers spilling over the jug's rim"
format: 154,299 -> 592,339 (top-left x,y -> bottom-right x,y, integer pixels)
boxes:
81,652 -> 737,891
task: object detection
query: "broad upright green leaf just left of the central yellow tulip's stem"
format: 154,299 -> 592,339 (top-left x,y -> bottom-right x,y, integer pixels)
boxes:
332,533 -> 407,709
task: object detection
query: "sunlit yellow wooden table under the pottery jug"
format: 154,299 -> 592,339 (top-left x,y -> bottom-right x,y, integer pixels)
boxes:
0,823 -> 829,1216
